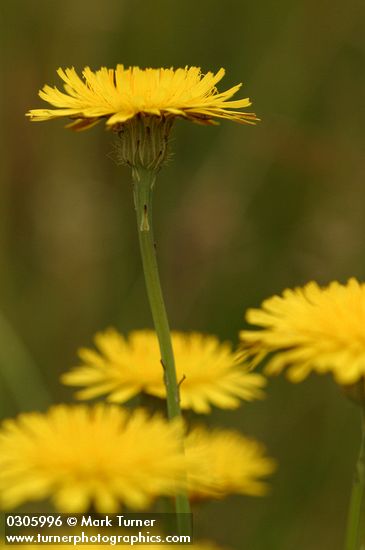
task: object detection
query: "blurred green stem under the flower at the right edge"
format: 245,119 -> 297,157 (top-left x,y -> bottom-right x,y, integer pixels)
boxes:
345,405 -> 365,550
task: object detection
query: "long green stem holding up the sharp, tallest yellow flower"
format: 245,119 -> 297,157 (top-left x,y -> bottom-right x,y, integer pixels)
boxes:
133,168 -> 191,534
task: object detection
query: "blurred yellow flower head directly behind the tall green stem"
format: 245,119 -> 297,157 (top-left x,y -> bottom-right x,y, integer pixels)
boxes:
62,329 -> 266,413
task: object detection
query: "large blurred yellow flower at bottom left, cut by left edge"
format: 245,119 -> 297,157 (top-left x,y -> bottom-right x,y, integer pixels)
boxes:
0,404 -> 186,512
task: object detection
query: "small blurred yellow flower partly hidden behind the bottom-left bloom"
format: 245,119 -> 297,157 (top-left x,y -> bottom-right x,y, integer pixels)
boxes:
185,427 -> 275,499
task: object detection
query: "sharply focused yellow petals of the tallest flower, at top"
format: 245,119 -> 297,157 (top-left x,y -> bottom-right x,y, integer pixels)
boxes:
27,65 -> 258,130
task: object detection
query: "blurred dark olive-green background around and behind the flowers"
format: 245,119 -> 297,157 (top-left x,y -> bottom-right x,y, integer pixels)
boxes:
0,0 -> 365,550
